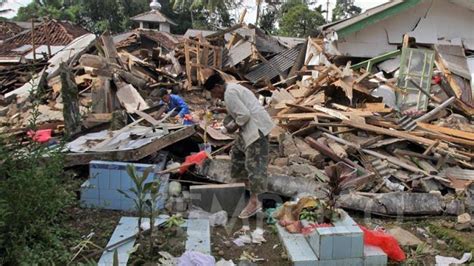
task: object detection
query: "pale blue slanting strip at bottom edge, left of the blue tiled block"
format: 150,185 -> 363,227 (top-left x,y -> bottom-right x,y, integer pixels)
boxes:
276,224 -> 318,266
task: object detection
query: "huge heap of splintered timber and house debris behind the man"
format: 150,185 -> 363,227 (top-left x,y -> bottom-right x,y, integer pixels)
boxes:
0,20 -> 474,222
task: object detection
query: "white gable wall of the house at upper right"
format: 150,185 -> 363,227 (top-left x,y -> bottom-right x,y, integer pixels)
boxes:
337,0 -> 474,57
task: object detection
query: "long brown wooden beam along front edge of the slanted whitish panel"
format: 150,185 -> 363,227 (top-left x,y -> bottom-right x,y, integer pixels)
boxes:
65,125 -> 196,167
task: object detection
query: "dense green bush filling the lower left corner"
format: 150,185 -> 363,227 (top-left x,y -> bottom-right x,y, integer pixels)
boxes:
0,84 -> 74,265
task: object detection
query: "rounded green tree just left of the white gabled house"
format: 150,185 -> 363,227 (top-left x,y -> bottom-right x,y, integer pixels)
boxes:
279,0 -> 325,37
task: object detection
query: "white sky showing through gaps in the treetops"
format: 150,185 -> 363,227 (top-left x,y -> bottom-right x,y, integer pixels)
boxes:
5,0 -> 388,23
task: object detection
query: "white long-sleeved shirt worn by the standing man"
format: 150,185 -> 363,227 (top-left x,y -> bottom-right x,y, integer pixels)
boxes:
224,83 -> 274,148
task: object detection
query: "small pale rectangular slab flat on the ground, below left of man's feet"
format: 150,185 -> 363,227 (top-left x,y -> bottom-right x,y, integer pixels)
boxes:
186,219 -> 211,255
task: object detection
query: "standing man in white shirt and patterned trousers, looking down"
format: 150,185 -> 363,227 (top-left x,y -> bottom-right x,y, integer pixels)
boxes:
204,74 -> 274,219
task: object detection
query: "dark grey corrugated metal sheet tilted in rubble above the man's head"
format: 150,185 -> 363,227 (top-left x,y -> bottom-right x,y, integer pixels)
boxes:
245,45 -> 302,83
